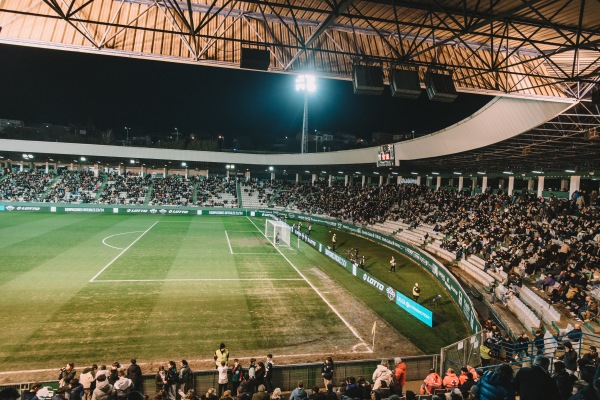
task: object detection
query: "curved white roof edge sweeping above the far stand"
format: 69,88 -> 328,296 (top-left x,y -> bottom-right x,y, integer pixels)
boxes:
0,97 -> 575,166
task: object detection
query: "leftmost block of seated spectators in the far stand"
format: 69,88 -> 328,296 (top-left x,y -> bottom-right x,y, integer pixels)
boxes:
0,170 -> 55,201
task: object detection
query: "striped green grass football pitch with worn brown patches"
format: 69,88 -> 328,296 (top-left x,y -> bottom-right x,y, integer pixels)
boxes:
0,213 -> 466,371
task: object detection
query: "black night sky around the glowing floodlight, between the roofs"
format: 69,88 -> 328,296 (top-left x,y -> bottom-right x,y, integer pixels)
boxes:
0,45 -> 490,143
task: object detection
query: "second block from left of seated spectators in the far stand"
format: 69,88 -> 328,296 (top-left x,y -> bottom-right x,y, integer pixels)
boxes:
43,170 -> 103,203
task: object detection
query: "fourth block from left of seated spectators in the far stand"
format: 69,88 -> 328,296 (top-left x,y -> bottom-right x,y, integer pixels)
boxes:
148,175 -> 199,206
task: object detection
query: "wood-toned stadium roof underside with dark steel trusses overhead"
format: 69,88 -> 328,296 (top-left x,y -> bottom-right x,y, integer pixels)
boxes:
0,0 -> 600,99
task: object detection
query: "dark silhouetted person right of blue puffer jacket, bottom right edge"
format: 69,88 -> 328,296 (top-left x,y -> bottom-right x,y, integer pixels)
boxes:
515,355 -> 559,400
